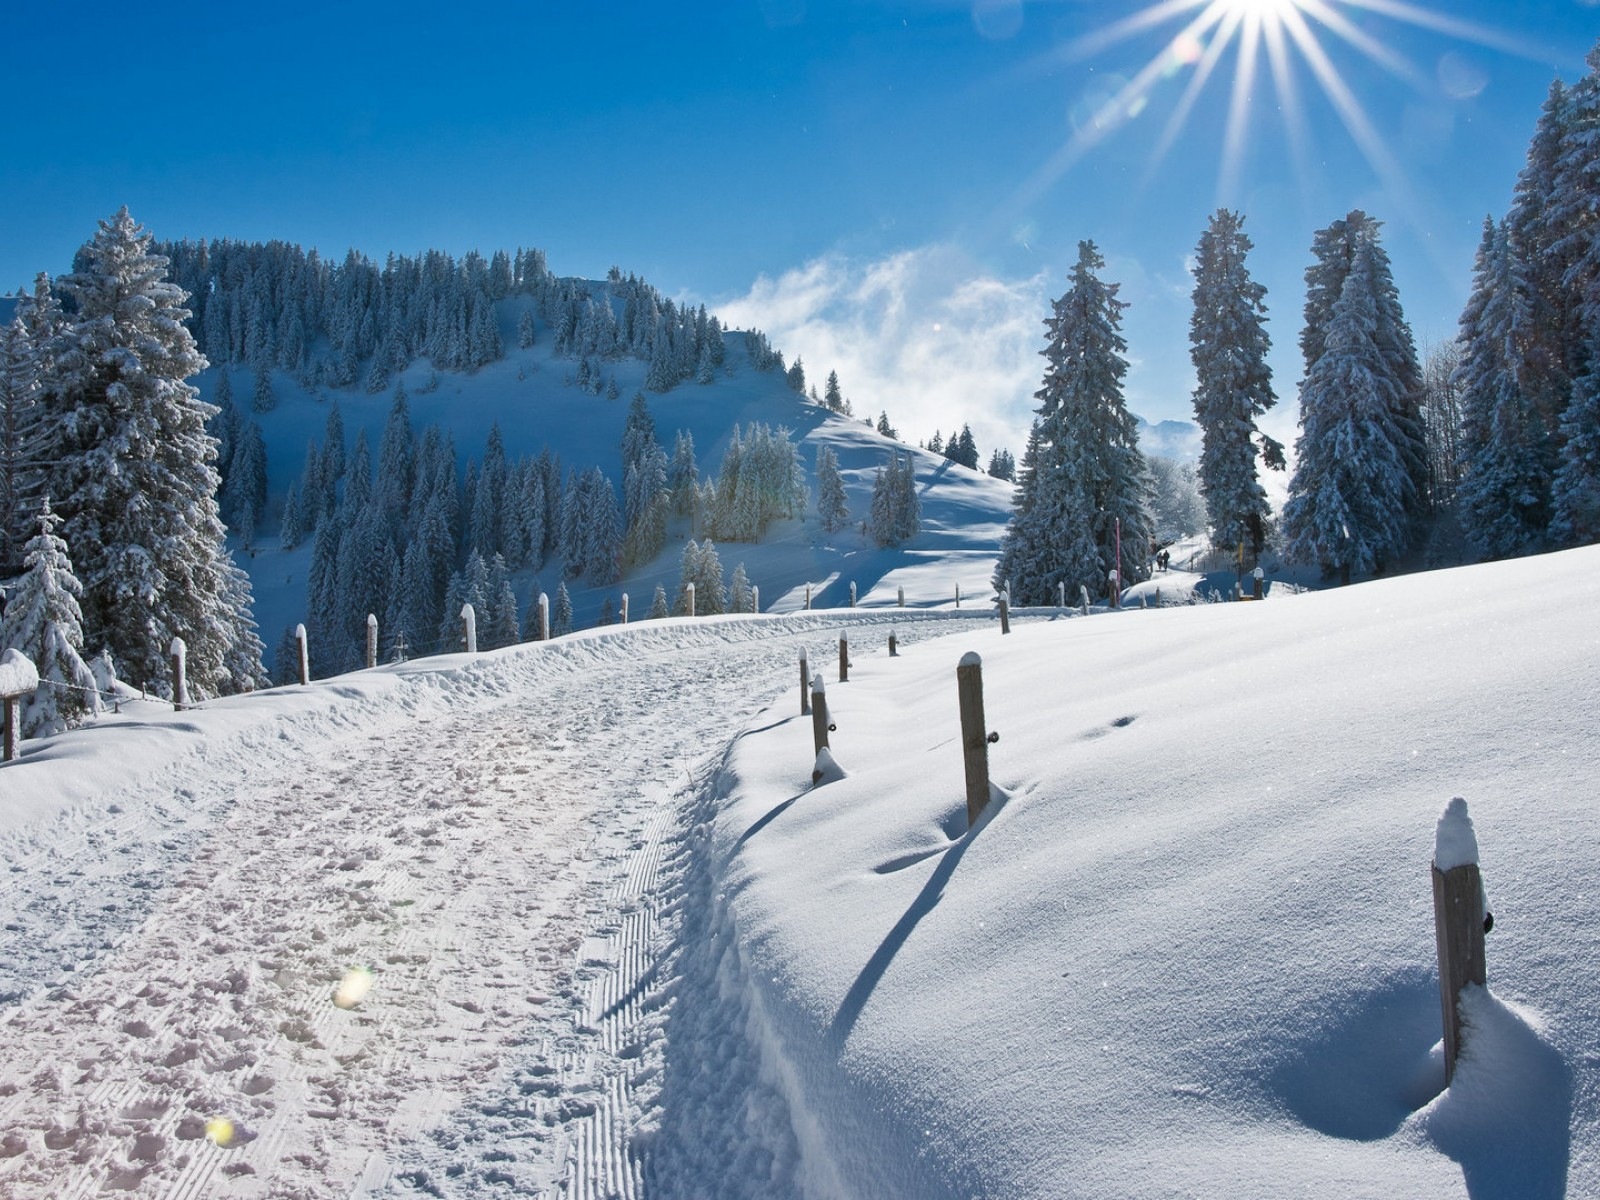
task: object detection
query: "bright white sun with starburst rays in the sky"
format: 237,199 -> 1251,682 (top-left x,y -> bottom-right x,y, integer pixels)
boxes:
1026,0 -> 1538,219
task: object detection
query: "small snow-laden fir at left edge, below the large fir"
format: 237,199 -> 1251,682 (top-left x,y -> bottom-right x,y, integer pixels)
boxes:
0,498 -> 99,738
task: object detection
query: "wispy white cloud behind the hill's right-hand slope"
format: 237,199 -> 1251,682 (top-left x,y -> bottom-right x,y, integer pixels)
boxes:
715,245 -> 1051,464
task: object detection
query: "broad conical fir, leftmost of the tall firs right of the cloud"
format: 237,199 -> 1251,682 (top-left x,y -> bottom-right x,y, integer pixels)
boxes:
995,242 -> 1150,605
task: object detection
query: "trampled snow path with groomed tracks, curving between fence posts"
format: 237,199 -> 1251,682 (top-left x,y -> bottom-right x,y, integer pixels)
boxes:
0,613 -> 976,1200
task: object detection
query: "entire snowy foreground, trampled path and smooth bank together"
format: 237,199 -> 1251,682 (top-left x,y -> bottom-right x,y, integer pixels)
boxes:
0,549 -> 1600,1200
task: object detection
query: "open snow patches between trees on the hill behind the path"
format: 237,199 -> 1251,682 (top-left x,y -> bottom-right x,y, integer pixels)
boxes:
212,299 -> 1013,659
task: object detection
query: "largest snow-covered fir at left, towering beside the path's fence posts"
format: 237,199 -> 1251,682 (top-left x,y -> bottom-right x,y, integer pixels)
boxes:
43,208 -> 262,698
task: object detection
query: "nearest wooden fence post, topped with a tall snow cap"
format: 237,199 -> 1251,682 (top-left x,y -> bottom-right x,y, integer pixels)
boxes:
1434,797 -> 1494,1088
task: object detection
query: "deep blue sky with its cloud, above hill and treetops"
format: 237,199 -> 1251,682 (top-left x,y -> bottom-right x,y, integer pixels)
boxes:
0,0 -> 1600,453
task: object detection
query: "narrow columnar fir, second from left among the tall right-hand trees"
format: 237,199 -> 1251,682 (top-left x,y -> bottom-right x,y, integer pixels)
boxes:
1189,208 -> 1283,557
